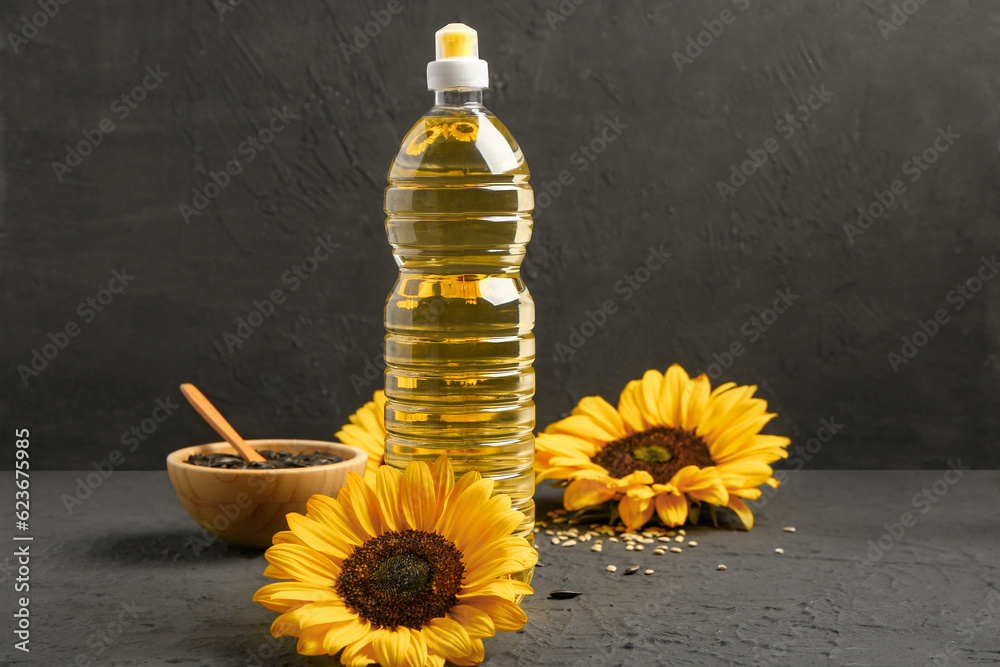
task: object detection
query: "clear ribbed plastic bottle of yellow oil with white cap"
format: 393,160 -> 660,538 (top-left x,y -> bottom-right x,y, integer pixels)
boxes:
385,23 -> 535,560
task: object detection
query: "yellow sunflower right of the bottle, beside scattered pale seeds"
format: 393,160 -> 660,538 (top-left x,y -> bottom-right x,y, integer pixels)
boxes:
535,364 -> 791,530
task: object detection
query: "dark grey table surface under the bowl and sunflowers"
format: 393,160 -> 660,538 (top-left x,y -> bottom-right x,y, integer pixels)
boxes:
0,471 -> 1000,666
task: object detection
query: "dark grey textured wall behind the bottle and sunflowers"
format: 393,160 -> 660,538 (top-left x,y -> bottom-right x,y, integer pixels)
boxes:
0,0 -> 1000,469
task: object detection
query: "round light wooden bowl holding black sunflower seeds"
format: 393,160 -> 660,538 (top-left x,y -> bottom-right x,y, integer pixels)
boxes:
167,440 -> 368,549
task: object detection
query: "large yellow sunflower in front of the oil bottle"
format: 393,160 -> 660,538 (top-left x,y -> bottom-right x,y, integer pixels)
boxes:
253,456 -> 538,667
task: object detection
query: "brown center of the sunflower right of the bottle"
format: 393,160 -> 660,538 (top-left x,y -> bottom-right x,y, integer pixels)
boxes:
591,426 -> 715,484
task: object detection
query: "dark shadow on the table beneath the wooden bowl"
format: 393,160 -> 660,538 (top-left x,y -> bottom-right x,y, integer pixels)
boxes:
85,529 -> 264,565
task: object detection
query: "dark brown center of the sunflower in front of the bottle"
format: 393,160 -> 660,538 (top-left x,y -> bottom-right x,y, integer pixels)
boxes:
336,530 -> 465,629
